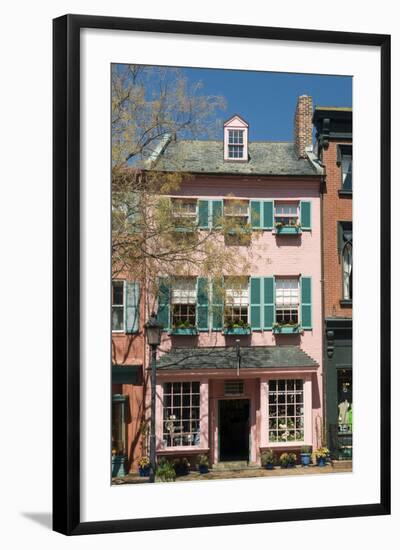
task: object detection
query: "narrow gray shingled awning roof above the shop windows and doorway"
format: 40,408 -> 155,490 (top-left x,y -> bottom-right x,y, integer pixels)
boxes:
157,346 -> 318,370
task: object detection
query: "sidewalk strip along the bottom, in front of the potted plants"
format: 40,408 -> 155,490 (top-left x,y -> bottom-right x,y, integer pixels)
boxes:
112,464 -> 352,485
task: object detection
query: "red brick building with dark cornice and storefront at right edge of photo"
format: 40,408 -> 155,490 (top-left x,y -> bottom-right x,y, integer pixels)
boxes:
313,106 -> 353,459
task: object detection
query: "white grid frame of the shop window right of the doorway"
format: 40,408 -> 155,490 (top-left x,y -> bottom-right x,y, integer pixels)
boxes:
267,378 -> 307,447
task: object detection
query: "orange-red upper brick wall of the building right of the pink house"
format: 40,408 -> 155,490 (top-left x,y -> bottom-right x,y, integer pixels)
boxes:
322,140 -> 352,317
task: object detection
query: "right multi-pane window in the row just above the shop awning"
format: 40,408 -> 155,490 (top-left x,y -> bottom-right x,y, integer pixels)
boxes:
275,278 -> 300,325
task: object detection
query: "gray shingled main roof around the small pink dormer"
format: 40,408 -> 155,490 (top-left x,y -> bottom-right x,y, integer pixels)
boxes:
155,140 -> 317,176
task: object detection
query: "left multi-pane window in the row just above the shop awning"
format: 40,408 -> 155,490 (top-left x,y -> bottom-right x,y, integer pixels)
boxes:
171,277 -> 197,328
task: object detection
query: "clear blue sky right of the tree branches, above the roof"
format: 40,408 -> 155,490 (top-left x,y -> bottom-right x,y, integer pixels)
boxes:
182,69 -> 352,141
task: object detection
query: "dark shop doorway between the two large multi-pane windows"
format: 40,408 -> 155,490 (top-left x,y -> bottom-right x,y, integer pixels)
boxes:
219,399 -> 250,462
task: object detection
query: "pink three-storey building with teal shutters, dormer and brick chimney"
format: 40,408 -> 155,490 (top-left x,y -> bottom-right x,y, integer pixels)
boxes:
148,96 -> 323,465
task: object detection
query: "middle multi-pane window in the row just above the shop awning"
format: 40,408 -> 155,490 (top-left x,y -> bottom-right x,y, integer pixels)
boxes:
224,277 -> 249,327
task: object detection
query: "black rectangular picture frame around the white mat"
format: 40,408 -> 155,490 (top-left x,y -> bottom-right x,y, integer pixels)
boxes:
53,15 -> 391,535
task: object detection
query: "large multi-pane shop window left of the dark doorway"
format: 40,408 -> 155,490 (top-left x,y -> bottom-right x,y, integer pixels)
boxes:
163,382 -> 200,447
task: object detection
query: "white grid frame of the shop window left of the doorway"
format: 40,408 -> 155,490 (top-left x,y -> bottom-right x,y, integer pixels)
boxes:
161,380 -> 201,449
